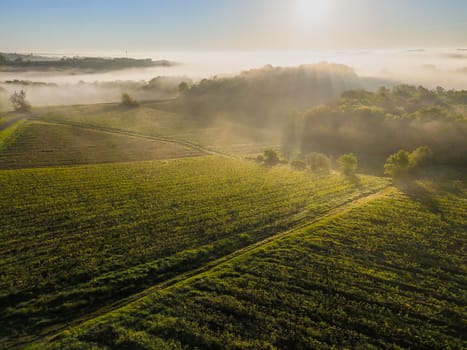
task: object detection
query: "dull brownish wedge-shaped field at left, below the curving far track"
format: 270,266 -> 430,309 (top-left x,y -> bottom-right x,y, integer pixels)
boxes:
0,121 -> 202,169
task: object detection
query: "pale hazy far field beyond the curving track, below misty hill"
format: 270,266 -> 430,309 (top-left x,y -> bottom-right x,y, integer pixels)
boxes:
35,101 -> 280,155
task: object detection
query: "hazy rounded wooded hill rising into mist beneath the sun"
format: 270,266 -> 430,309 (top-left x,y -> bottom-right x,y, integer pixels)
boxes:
180,63 -> 394,124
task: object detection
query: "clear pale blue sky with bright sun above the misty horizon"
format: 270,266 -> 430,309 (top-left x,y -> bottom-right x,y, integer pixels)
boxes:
0,0 -> 467,52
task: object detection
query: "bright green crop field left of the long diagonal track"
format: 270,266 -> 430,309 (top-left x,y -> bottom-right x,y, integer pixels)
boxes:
0,157 -> 388,344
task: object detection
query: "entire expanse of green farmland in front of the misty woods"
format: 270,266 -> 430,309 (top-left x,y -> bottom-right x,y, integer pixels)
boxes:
0,102 -> 467,349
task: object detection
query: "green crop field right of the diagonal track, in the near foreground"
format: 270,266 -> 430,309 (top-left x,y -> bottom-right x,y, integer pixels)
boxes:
39,181 -> 467,349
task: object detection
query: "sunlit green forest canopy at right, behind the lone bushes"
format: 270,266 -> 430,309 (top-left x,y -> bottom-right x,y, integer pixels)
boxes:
301,85 -> 467,165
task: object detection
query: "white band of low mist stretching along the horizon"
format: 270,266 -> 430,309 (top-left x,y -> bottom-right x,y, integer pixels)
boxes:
0,48 -> 467,106
